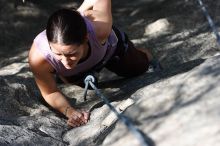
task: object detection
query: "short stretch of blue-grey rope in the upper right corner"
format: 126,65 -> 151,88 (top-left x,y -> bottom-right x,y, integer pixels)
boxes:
197,0 -> 220,46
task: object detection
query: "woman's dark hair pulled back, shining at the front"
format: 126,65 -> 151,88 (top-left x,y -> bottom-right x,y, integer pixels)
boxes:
46,9 -> 87,45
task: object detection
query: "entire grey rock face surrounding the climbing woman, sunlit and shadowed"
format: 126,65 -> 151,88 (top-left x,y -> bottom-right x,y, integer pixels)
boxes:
0,0 -> 220,146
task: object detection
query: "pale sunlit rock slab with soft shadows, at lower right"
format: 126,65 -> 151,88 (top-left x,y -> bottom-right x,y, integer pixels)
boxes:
104,56 -> 220,146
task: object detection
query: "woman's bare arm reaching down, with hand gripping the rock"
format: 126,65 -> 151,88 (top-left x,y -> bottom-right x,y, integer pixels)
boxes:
29,45 -> 88,127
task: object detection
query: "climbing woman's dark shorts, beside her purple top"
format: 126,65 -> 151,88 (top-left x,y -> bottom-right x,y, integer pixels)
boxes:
105,27 -> 149,77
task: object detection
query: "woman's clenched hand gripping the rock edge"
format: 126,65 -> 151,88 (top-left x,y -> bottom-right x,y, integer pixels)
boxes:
67,108 -> 90,127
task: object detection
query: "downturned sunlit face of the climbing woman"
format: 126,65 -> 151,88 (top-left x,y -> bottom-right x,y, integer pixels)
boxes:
49,43 -> 85,69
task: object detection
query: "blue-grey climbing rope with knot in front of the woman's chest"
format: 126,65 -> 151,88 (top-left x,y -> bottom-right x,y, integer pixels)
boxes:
84,75 -> 150,146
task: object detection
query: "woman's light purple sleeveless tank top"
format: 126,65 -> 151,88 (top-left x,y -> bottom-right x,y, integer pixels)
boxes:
34,17 -> 118,76
